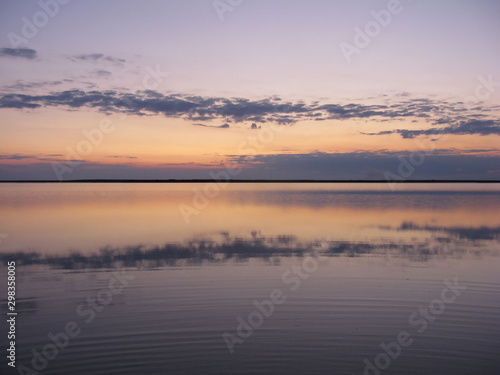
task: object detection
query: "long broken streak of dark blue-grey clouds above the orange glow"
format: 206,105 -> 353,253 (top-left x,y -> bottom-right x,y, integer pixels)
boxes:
0,89 -> 500,138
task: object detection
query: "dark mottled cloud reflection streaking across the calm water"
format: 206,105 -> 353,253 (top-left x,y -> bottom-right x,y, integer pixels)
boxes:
1,222 -> 500,270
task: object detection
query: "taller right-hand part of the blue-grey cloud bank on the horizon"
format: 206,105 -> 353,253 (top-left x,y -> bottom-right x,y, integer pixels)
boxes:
227,150 -> 500,180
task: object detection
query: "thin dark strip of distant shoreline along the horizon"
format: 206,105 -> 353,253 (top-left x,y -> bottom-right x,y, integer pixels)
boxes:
0,179 -> 500,184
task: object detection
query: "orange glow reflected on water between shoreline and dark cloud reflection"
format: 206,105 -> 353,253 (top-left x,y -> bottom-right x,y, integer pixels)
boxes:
0,184 -> 500,255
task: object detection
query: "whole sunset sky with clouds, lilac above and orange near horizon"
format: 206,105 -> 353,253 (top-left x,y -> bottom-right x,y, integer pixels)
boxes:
0,0 -> 500,180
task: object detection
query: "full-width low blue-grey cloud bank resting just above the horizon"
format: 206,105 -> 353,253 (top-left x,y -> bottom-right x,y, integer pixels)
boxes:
0,150 -> 500,181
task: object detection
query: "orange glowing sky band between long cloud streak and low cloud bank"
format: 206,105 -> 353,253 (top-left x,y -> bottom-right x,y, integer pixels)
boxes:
2,109 -> 499,169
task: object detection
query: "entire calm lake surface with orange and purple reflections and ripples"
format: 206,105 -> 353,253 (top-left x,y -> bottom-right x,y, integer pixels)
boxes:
0,184 -> 500,375
